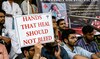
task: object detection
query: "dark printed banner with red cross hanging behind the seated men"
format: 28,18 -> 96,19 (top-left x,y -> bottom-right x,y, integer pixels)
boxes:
37,0 -> 100,35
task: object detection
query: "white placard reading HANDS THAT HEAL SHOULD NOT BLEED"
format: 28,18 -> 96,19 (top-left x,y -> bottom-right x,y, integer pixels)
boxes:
14,13 -> 54,47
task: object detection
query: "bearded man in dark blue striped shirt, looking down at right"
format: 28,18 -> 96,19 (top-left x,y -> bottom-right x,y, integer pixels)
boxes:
77,25 -> 100,57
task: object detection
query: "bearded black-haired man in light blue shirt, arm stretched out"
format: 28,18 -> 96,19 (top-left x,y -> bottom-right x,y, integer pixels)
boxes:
62,29 -> 100,59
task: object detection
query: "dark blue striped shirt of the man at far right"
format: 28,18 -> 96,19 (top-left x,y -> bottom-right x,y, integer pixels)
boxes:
76,38 -> 100,53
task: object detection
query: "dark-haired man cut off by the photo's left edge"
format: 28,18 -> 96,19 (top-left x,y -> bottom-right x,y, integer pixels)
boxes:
0,9 -> 11,53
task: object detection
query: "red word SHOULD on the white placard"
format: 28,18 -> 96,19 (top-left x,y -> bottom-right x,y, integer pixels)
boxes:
26,29 -> 48,37
